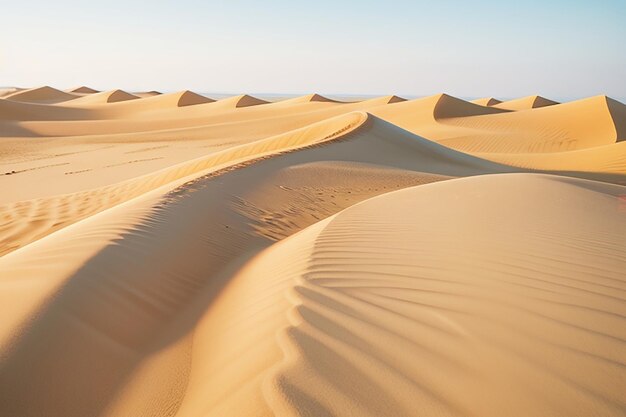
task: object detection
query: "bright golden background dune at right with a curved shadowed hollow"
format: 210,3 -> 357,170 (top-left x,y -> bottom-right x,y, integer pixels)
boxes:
371,95 -> 626,154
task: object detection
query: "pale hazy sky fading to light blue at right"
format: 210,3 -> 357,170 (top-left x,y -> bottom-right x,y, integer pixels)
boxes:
0,0 -> 626,99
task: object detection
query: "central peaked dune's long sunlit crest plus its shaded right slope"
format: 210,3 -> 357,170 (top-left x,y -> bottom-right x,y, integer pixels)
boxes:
0,112 -> 512,255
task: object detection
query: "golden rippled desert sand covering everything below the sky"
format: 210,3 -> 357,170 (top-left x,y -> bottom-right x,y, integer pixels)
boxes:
0,86 -> 626,417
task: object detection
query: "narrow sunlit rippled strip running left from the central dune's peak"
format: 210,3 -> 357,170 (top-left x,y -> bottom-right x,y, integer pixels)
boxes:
0,113 -> 366,256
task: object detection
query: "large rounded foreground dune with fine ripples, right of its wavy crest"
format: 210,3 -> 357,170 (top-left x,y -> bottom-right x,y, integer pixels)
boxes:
256,175 -> 626,416
